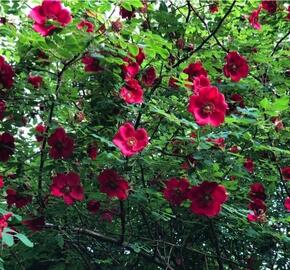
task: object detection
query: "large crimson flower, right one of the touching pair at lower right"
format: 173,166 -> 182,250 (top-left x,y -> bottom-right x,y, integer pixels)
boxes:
188,181 -> 228,217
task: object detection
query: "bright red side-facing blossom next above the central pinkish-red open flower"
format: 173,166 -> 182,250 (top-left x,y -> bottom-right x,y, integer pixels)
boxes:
120,78 -> 144,104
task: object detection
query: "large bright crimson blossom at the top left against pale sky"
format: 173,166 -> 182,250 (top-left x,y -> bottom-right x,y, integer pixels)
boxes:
29,0 -> 72,36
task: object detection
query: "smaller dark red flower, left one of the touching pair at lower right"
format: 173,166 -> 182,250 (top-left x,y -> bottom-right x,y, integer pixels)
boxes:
163,178 -> 189,205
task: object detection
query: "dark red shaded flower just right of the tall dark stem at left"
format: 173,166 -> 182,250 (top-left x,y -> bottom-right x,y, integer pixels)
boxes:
47,128 -> 74,159
